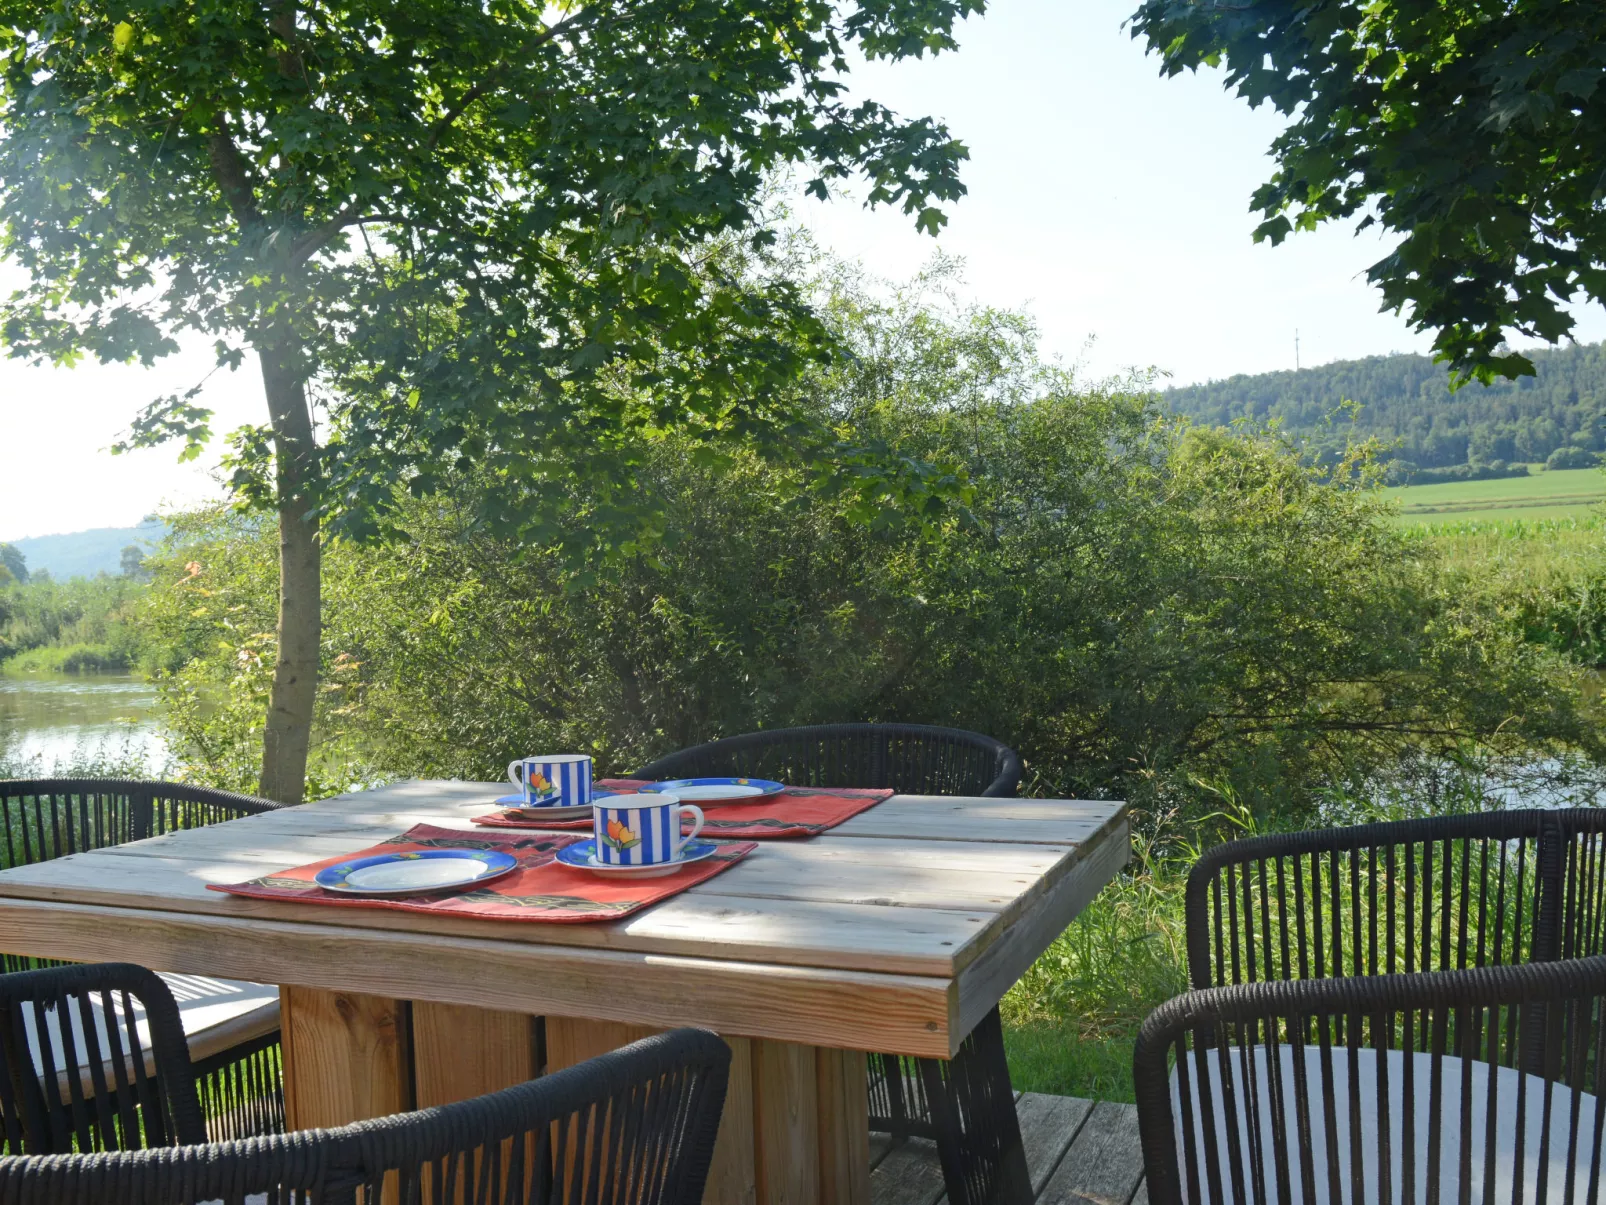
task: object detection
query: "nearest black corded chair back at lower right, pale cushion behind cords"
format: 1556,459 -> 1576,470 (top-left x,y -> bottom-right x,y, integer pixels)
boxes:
1134,958 -> 1606,1205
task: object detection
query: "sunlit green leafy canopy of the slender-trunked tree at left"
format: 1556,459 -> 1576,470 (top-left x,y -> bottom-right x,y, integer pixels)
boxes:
0,0 -> 983,543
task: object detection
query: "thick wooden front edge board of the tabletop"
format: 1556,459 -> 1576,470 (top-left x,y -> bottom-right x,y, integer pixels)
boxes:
0,900 -> 964,1059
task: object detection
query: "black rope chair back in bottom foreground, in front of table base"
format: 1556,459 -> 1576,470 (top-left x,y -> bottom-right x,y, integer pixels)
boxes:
0,1030 -> 731,1205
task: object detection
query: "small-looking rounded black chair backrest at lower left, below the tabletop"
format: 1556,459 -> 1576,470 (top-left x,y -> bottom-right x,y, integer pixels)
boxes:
0,962 -> 206,1162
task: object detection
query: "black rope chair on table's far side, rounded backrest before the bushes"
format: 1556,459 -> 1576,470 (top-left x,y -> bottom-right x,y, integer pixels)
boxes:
631,723 -> 1031,1205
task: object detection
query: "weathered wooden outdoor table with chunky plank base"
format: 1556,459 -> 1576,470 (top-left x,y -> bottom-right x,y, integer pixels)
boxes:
0,782 -> 1129,1205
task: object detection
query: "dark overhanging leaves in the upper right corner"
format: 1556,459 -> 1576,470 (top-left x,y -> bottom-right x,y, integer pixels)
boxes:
1132,0 -> 1606,381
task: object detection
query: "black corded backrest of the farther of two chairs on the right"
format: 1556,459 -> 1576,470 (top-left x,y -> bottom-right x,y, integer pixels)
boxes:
1185,808 -> 1606,988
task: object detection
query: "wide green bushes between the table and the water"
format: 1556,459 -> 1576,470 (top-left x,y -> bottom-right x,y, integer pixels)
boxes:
141,268 -> 1603,816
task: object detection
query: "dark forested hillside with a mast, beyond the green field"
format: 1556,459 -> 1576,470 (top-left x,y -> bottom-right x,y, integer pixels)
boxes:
1166,344 -> 1606,472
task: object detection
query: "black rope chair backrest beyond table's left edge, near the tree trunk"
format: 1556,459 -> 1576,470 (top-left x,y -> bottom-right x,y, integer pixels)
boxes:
0,778 -> 284,869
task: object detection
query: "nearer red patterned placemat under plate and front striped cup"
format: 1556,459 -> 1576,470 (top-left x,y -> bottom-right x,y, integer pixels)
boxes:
207,824 -> 755,924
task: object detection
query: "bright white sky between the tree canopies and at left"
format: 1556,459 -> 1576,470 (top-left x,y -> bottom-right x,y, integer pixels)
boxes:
0,0 -> 1606,540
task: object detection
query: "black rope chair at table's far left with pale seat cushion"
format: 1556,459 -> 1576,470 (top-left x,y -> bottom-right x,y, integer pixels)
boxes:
0,778 -> 284,1139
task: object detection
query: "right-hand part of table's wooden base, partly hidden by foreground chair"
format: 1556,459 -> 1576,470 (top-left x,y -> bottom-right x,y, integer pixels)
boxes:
546,1017 -> 870,1205
